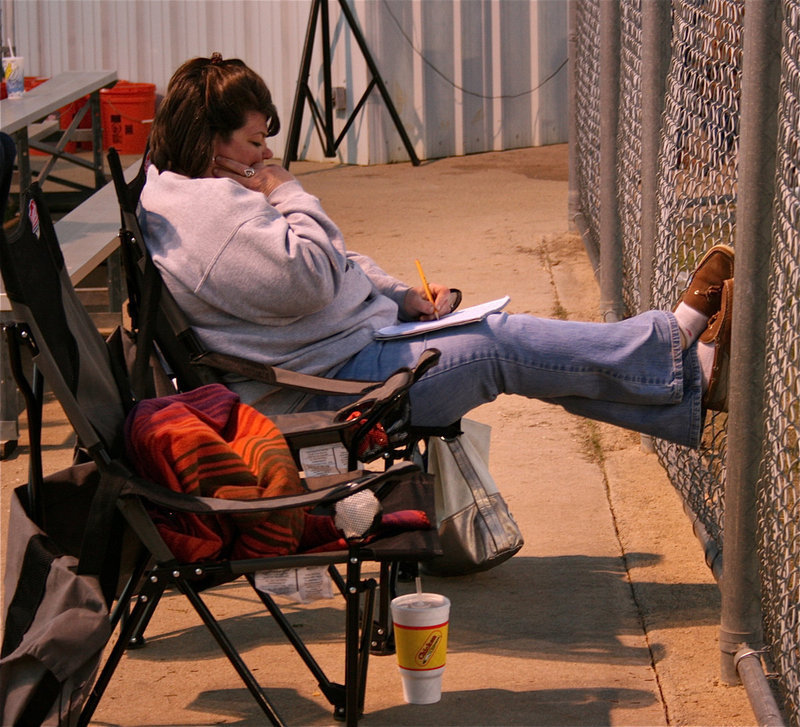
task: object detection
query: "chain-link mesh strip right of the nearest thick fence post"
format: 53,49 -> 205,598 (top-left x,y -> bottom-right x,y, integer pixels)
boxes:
758,0 -> 800,724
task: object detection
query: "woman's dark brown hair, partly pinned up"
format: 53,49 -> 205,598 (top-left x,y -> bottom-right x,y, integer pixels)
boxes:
150,53 -> 280,178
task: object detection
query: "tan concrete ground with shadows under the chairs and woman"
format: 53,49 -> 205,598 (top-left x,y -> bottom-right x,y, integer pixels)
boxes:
2,145 -> 755,727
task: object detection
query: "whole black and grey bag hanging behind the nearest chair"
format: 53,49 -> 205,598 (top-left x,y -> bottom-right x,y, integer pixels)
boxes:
0,463 -> 121,727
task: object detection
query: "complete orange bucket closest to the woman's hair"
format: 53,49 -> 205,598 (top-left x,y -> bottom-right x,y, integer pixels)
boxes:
100,81 -> 156,154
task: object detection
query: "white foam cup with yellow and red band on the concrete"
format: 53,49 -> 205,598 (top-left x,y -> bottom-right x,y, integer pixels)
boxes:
391,593 -> 450,704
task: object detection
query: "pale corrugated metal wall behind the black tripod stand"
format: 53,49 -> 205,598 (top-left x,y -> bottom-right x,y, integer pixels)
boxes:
2,0 -> 567,164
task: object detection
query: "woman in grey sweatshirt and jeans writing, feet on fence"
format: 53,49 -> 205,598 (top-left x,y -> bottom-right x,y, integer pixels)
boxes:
140,54 -> 733,447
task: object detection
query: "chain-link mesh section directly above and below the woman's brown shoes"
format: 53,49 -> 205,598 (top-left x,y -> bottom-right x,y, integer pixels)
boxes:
652,0 -> 743,576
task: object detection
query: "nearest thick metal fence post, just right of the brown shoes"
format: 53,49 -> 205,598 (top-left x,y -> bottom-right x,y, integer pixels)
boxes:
720,0 -> 781,684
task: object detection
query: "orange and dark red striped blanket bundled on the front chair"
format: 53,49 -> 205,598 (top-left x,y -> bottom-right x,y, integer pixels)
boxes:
126,384 -> 306,562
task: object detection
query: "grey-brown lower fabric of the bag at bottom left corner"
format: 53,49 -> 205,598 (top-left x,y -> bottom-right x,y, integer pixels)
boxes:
0,487 -> 111,727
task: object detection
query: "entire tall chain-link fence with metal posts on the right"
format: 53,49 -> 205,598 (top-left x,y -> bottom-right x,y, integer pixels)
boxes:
570,0 -> 800,727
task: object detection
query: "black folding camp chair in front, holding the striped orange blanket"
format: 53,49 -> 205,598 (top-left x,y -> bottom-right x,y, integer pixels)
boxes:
0,184 -> 440,725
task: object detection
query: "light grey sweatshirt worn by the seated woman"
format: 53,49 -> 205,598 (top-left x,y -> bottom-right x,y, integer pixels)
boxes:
140,166 -> 409,390
